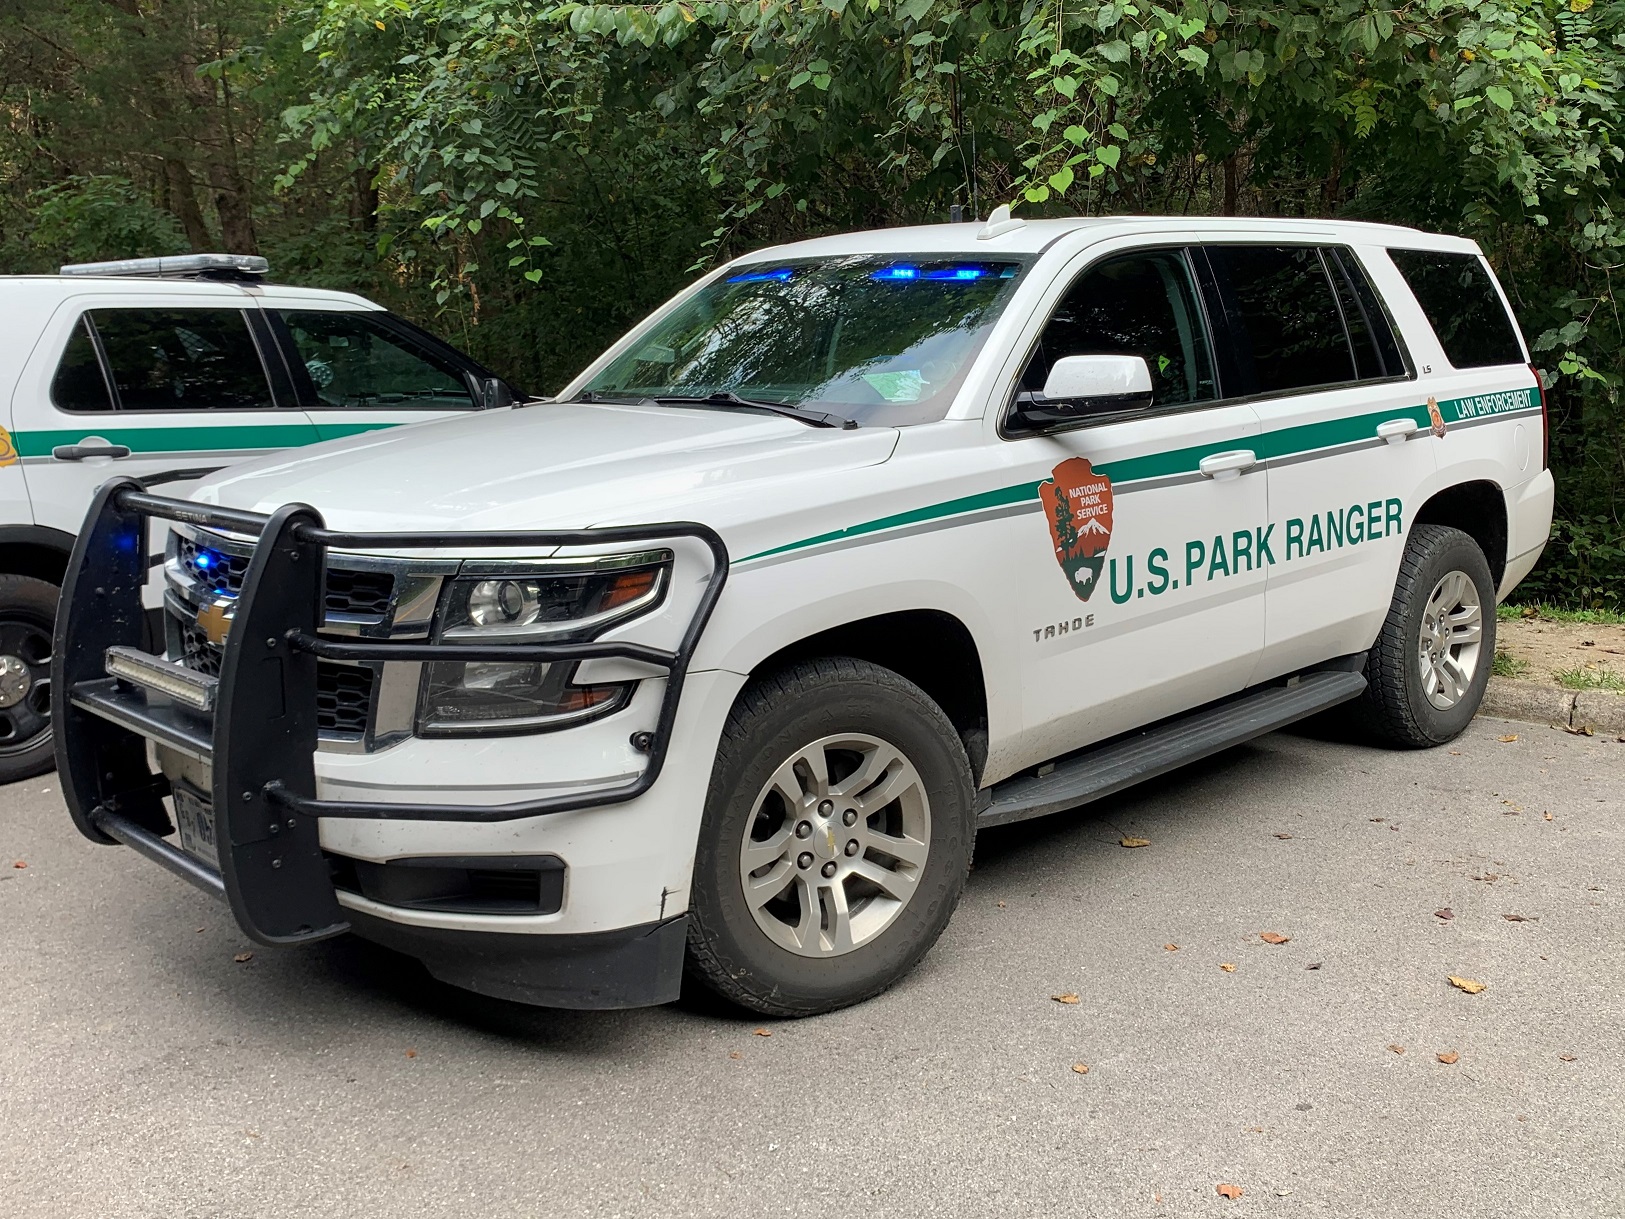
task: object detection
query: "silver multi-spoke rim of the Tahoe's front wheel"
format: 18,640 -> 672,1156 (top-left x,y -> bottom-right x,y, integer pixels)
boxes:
739,733 -> 931,957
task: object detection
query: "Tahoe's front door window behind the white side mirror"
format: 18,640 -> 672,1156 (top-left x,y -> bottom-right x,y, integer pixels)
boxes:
1021,250 -> 1219,406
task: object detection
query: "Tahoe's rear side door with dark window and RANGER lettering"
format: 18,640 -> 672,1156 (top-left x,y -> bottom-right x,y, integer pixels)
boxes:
1203,244 -> 1437,681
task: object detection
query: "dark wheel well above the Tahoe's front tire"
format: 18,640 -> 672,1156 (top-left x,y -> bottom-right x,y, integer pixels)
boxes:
754,610 -> 988,782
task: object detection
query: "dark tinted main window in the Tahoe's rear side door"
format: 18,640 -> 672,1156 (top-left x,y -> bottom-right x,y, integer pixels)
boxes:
1206,245 -> 1357,393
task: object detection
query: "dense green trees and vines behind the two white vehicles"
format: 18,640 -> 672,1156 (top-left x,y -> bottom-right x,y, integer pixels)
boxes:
0,0 -> 1625,606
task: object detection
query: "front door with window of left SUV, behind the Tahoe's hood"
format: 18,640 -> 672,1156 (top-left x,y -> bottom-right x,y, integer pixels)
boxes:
265,301 -> 489,440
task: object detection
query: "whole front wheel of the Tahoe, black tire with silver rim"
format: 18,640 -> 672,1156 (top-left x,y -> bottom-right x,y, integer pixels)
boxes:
687,658 -> 975,1016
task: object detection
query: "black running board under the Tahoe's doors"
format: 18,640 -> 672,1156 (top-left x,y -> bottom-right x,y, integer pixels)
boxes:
977,673 -> 1365,829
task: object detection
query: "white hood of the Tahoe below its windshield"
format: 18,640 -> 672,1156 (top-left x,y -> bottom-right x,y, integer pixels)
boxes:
192,403 -> 897,531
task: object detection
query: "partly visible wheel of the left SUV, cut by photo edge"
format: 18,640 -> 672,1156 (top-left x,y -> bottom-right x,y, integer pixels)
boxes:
0,575 -> 60,783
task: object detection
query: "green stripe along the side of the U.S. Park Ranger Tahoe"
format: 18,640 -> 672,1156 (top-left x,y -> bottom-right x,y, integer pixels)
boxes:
739,387 -> 1541,562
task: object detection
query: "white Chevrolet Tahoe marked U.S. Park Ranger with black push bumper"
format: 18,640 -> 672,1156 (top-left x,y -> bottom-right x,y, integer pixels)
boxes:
52,210 -> 1552,1016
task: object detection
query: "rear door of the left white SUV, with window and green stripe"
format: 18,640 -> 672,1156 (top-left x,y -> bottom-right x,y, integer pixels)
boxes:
13,293 -> 317,533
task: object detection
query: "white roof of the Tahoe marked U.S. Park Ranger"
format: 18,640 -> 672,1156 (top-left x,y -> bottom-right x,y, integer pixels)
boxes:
738,216 -> 1477,263
